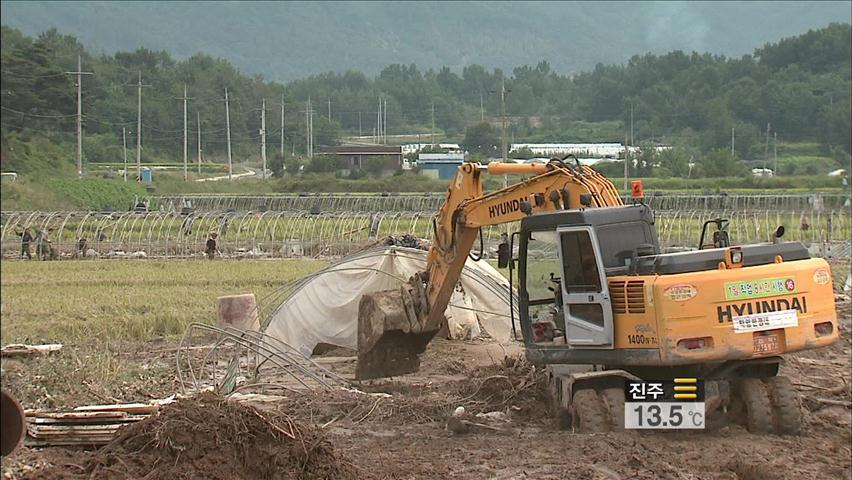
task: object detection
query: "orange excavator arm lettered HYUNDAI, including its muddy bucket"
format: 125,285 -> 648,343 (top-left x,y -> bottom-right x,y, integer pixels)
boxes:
355,160 -> 622,379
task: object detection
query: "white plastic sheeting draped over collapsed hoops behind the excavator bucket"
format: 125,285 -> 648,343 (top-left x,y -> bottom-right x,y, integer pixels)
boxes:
265,247 -> 512,355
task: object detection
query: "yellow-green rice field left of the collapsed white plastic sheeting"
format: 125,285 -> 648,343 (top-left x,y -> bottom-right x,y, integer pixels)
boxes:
0,259 -> 325,344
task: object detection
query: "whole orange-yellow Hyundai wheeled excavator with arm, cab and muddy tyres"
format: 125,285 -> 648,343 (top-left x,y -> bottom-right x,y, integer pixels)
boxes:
356,157 -> 839,434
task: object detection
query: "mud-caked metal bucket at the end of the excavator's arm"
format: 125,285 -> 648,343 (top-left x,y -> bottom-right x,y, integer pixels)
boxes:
355,286 -> 437,380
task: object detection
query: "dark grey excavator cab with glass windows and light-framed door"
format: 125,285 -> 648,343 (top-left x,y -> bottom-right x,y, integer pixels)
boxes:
506,205 -> 658,363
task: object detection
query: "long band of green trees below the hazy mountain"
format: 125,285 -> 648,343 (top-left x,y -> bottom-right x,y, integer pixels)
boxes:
0,24 -> 852,177
